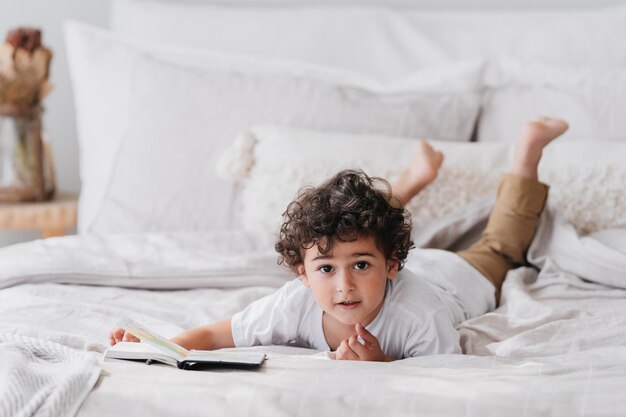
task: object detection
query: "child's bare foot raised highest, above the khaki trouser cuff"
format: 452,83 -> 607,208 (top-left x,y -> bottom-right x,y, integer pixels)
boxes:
512,116 -> 569,178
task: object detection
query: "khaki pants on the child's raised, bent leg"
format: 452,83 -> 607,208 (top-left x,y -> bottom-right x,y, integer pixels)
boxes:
458,174 -> 548,303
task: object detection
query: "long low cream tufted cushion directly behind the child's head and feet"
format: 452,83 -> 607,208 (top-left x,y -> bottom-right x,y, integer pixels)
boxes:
220,126 -> 626,238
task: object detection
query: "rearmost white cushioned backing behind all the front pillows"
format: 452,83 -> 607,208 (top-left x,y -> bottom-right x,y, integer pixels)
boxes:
111,0 -> 626,80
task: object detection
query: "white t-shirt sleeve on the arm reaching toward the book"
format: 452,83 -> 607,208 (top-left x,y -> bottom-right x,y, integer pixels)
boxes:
231,279 -> 307,347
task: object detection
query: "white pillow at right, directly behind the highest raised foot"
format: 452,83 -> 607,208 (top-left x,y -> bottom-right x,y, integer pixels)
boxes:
478,58 -> 626,142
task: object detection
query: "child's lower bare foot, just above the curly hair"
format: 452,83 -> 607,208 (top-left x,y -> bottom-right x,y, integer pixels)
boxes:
392,140 -> 443,205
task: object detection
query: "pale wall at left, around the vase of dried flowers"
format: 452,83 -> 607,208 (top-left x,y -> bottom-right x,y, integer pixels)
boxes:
0,0 -> 111,246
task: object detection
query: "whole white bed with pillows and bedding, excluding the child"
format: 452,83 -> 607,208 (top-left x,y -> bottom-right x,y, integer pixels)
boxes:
0,0 -> 626,417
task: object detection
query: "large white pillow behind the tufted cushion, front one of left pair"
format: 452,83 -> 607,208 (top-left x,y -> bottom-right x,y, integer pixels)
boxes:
75,27 -> 482,234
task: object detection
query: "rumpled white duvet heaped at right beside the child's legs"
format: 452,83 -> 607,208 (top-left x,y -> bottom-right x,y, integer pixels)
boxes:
459,206 -> 626,358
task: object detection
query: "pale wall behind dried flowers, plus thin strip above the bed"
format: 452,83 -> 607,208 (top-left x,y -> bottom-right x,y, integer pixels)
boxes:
0,0 -> 626,246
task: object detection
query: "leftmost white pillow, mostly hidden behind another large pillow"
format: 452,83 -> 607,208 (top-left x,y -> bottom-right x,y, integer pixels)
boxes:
64,21 -> 276,233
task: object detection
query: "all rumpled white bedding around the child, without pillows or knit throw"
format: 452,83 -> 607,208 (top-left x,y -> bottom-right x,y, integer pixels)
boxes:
0,203 -> 626,417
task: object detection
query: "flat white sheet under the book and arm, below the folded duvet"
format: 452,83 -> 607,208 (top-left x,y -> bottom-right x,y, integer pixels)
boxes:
0,284 -> 626,417
